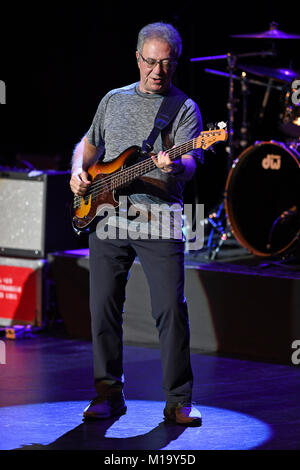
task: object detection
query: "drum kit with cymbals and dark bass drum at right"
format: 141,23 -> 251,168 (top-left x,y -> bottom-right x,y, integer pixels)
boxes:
191,22 -> 300,260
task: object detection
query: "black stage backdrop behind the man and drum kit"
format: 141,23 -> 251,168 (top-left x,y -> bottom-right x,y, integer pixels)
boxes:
0,0 -> 300,211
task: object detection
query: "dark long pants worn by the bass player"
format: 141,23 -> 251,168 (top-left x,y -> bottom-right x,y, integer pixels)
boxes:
89,233 -> 193,403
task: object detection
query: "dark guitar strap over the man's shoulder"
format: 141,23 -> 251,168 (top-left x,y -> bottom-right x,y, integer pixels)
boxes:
142,86 -> 188,153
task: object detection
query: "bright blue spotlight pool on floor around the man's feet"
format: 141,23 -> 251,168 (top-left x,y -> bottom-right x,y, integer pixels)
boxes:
0,400 -> 272,450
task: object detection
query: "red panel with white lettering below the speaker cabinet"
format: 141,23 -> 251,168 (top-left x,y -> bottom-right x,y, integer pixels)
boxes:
0,265 -> 37,324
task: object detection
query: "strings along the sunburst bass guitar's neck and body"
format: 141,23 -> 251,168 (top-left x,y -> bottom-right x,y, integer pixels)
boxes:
74,131 -> 220,209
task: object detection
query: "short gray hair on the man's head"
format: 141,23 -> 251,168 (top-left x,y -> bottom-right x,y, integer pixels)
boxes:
137,22 -> 182,59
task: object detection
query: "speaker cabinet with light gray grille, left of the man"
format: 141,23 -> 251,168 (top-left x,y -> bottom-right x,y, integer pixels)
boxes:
0,171 -> 78,258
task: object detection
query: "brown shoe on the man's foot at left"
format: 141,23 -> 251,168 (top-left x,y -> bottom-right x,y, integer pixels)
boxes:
83,384 -> 127,419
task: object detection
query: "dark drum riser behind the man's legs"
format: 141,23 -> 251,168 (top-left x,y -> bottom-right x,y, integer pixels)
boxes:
49,255 -> 300,364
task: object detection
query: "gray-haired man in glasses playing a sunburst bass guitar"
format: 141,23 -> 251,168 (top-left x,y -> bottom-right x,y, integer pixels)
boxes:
70,23 -> 202,425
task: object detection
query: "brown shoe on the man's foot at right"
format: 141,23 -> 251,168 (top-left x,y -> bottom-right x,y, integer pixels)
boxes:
164,403 -> 202,426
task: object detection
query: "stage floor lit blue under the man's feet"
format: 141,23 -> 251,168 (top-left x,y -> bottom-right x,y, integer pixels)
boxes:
0,332 -> 300,452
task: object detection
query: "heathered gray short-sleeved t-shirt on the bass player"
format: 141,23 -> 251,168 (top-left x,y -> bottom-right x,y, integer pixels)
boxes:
86,83 -> 202,239
